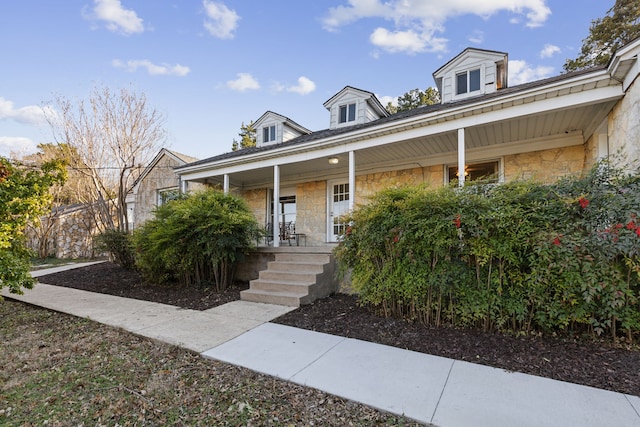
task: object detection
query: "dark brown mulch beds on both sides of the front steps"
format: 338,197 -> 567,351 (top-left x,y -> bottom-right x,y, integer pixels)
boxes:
39,263 -> 640,396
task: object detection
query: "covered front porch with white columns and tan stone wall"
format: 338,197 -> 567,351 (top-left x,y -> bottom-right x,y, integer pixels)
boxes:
178,70 -> 623,248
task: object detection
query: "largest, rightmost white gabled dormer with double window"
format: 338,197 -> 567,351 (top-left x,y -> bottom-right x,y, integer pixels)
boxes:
433,47 -> 508,104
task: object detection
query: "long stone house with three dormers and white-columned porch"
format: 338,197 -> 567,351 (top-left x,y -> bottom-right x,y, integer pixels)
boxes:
176,39 -> 640,252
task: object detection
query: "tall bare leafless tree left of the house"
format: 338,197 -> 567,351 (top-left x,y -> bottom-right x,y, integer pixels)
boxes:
47,87 -> 166,231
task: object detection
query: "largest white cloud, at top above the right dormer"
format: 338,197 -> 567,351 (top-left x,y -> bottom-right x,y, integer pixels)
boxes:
323,0 -> 551,54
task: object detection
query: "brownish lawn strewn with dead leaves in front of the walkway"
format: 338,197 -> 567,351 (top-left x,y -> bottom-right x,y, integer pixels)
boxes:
0,300 -> 424,426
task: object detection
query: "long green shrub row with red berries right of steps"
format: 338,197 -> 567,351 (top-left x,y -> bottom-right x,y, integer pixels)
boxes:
336,163 -> 640,338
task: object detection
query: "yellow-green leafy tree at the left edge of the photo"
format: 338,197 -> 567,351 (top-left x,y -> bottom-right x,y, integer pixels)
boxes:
0,157 -> 66,294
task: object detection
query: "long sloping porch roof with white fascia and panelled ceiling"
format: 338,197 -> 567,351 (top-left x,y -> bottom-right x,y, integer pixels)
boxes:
176,59 -> 624,188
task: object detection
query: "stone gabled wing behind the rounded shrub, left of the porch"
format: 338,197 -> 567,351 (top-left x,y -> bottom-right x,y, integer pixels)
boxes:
125,148 -> 198,230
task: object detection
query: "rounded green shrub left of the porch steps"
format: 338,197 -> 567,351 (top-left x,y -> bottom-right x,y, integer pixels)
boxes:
134,189 -> 261,290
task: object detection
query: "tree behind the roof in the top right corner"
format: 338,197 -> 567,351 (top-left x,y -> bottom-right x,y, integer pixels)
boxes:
564,0 -> 640,72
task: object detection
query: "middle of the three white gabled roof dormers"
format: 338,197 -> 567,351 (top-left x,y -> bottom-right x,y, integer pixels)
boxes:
323,86 -> 389,129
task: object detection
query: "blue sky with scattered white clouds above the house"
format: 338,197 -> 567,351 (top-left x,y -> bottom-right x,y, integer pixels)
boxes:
0,0 -> 614,158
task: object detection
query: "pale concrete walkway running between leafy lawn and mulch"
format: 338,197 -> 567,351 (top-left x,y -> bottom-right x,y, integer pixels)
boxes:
3,267 -> 640,427
